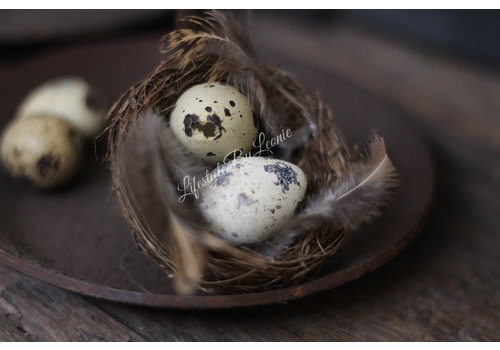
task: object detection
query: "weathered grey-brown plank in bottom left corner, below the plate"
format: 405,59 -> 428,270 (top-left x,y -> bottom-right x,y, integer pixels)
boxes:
0,266 -> 142,341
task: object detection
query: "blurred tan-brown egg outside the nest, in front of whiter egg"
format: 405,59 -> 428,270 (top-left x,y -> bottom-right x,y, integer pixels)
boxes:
0,115 -> 84,189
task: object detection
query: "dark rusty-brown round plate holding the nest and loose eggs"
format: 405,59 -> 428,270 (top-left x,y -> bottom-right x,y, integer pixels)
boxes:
0,35 -> 434,309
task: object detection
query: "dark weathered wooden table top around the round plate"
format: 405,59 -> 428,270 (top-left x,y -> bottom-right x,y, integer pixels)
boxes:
0,11 -> 500,341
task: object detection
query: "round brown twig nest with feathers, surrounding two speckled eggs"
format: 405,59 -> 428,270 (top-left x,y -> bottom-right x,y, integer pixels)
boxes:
104,12 -> 394,294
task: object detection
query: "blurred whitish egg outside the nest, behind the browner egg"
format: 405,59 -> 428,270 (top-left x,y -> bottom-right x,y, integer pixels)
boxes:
15,76 -> 107,138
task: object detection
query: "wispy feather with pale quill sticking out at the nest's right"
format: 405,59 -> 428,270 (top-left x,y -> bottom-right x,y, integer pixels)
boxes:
260,136 -> 397,259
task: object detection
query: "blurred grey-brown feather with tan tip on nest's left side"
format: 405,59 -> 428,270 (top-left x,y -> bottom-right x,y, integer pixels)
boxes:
117,112 -> 210,294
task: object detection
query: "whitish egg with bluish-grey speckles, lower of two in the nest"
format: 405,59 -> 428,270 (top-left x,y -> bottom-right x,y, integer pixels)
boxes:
199,157 -> 307,245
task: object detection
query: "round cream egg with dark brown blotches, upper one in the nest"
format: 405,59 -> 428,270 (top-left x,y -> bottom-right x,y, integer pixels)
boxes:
170,83 -> 258,165
